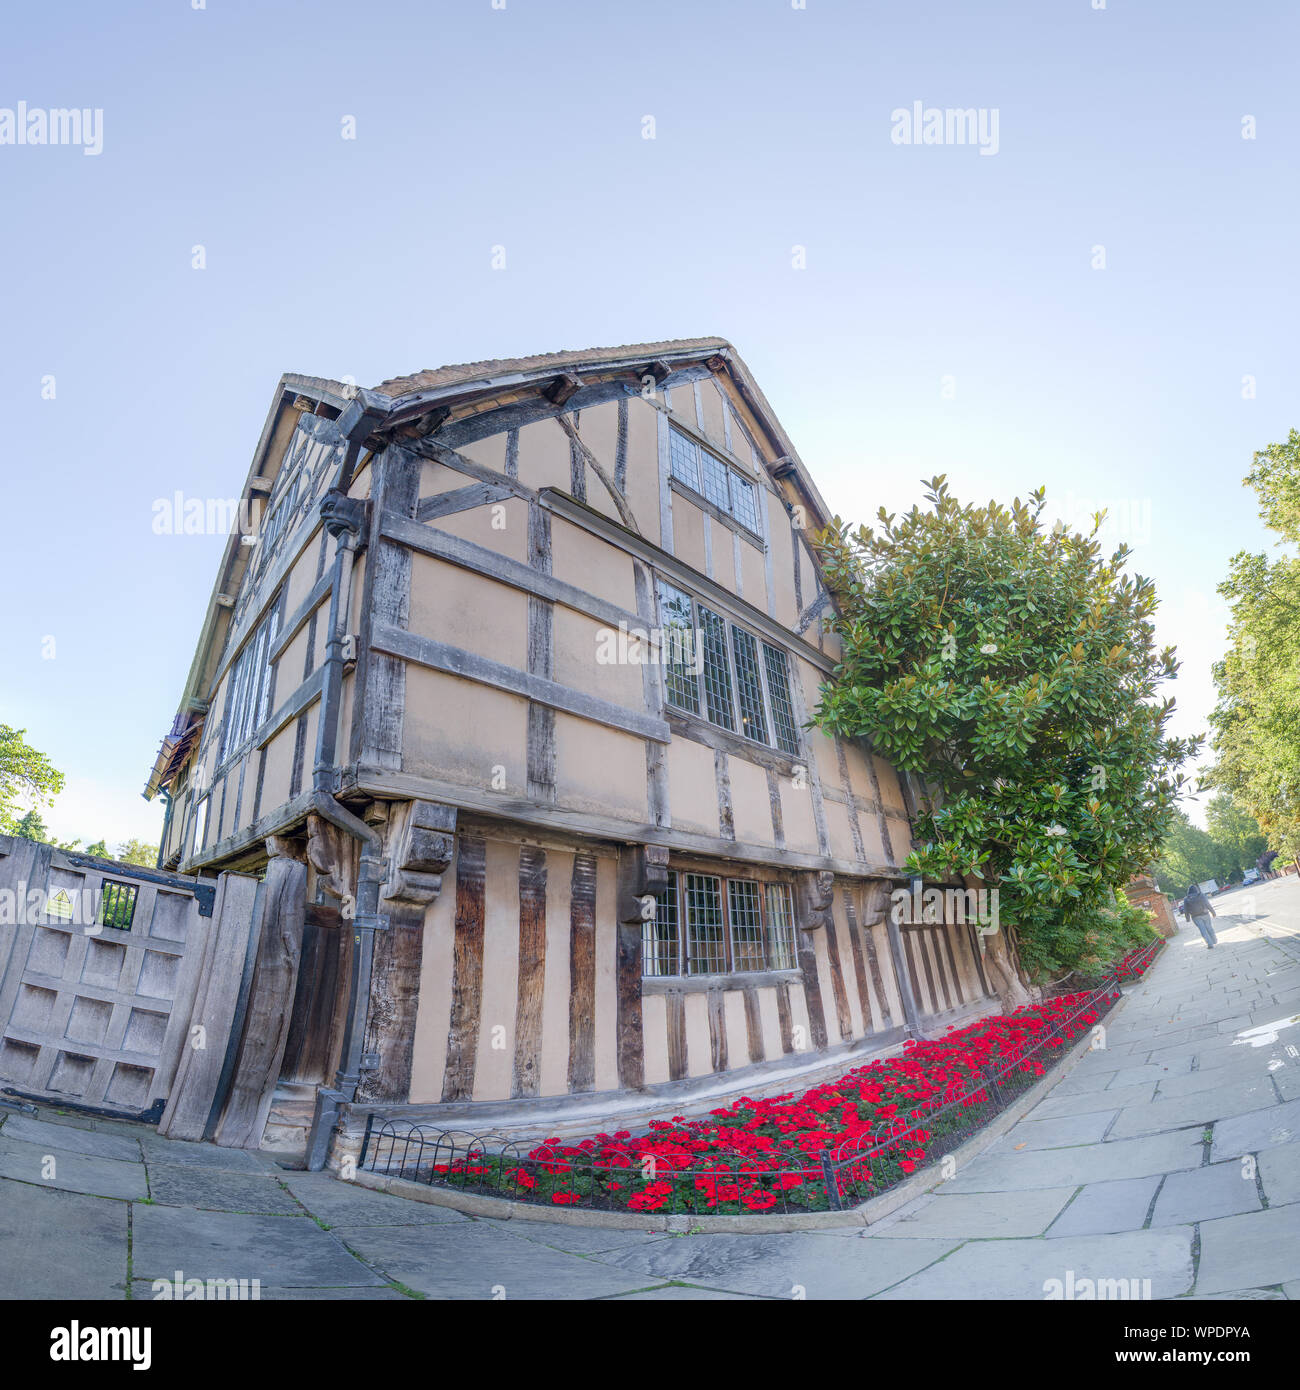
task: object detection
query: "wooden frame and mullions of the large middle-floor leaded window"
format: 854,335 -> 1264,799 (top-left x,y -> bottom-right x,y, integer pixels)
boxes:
655,574 -> 806,760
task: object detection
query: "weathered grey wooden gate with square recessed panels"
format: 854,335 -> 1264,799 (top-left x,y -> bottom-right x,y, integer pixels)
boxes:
0,835 -> 256,1122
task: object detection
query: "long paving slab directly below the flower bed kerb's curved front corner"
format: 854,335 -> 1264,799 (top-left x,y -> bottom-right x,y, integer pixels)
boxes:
601,1234 -> 958,1298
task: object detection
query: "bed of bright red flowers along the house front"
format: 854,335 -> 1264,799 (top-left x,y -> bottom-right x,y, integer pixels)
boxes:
428,994 -> 1116,1212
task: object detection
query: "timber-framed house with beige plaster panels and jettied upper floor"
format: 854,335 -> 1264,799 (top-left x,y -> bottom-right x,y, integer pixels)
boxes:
146,338 -> 994,1163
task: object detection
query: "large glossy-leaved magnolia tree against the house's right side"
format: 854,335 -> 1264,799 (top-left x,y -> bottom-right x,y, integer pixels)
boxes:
816,475 -> 1200,1008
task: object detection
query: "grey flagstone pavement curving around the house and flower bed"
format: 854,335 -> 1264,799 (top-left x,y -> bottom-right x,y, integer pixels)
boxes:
0,880 -> 1300,1300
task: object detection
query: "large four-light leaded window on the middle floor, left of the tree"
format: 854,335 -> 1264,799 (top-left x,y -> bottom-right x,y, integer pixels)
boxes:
659,580 -> 799,756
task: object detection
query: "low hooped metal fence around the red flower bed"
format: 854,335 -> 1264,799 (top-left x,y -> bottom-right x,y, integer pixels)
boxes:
359,960 -> 1144,1215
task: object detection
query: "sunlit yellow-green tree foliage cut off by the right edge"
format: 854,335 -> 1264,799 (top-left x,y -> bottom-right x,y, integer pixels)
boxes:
1207,430 -> 1300,859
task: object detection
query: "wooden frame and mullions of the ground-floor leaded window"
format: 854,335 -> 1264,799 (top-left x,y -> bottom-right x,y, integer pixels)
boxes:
641,865 -> 799,983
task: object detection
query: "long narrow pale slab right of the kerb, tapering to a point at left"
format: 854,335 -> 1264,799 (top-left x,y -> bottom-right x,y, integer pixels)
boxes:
940,1130 -> 1203,1193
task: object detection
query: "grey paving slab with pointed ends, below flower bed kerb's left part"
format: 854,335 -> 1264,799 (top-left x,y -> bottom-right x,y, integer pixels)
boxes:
334,1222 -> 664,1300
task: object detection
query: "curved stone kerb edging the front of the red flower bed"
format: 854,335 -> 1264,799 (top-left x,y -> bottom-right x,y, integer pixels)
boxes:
346,990 -> 1128,1236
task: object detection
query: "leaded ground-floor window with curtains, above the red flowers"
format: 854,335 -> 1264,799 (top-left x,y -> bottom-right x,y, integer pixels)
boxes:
641,869 -> 795,977
